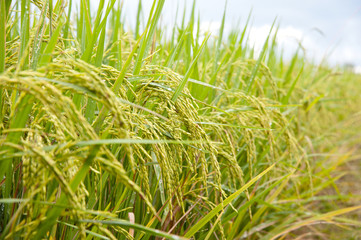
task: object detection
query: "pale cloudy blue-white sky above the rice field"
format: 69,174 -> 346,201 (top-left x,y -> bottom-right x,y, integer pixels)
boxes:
93,0 -> 361,72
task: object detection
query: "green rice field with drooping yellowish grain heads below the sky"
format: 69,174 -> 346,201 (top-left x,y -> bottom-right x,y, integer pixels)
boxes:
0,0 -> 361,239
